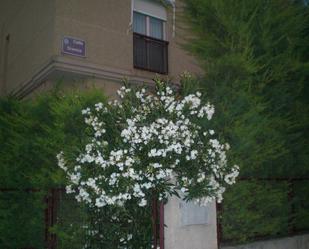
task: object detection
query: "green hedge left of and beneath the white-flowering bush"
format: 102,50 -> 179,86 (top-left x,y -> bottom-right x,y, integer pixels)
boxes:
0,88 -> 153,249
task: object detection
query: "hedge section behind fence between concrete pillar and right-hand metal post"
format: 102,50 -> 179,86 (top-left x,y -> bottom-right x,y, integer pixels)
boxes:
221,181 -> 290,242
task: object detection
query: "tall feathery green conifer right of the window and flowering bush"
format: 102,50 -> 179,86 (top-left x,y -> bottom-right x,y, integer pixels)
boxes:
186,0 -> 309,241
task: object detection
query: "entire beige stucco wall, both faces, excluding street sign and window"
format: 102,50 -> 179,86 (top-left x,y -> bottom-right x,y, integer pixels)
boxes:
0,0 -> 200,97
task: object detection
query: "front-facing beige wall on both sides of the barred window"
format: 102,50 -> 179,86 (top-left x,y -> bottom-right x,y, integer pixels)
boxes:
54,0 -> 199,81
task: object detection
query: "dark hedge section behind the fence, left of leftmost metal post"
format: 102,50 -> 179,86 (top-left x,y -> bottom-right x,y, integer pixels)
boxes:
0,191 -> 45,249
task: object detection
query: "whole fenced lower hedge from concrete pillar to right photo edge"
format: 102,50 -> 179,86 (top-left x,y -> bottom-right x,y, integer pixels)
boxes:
218,180 -> 309,244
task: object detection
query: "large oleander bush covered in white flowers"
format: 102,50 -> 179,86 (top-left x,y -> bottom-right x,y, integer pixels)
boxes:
57,76 -> 238,248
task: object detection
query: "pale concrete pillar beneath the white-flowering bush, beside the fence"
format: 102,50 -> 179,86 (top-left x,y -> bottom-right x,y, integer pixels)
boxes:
164,197 -> 218,249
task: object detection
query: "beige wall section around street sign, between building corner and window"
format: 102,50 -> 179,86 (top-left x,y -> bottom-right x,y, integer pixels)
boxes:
54,0 -> 133,72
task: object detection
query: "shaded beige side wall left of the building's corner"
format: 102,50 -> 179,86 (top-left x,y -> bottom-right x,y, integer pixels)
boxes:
0,0 -> 55,93
